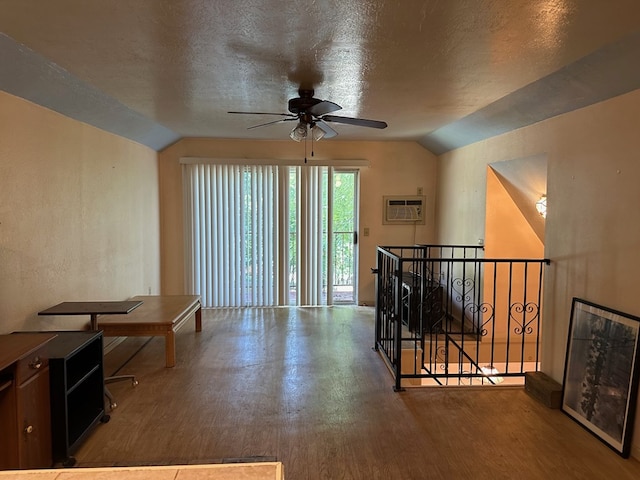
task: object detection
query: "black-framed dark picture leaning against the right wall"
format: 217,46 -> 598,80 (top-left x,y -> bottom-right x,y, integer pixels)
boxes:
562,297 -> 640,458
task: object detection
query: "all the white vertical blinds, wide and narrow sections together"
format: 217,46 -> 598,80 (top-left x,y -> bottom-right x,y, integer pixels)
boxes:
183,164 -> 328,307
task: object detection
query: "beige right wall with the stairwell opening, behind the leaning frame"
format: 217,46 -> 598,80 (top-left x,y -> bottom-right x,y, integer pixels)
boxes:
437,91 -> 640,456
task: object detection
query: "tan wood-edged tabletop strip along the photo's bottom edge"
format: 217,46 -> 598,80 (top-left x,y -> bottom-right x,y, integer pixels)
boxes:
0,462 -> 284,480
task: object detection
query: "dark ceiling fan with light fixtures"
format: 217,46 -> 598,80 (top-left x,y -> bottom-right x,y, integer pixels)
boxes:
228,89 -> 387,142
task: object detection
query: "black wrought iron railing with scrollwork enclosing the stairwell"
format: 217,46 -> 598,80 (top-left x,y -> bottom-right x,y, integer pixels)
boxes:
374,245 -> 549,390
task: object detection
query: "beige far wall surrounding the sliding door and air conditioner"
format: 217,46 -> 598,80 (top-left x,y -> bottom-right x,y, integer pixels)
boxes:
159,139 -> 436,305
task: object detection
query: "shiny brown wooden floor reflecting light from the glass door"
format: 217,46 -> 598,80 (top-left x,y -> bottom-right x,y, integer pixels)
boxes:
76,307 -> 640,480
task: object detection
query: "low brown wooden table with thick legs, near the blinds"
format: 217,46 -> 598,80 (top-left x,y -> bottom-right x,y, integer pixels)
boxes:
98,295 -> 202,367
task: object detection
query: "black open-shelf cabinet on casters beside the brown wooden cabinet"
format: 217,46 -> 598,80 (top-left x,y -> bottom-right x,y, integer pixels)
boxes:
47,331 -> 109,466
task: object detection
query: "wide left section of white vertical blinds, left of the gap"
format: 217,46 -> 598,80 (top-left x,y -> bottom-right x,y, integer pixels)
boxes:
183,164 -> 279,307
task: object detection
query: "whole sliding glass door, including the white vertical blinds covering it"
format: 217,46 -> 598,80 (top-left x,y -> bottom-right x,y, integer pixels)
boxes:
183,164 -> 357,307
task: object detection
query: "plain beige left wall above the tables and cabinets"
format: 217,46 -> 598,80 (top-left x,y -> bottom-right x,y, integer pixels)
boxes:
0,92 -> 160,333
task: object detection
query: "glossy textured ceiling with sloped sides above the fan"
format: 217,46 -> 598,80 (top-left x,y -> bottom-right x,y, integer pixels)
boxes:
0,0 -> 640,153
